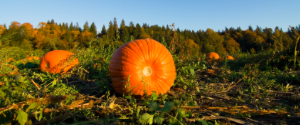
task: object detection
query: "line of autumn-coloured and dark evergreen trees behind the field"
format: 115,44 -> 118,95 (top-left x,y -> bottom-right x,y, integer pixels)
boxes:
0,18 -> 300,55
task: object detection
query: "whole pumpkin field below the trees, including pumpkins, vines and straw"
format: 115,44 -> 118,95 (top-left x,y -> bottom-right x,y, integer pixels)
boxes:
0,23 -> 300,125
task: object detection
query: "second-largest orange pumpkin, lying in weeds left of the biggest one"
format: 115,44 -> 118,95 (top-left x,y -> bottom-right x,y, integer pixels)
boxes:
40,50 -> 79,73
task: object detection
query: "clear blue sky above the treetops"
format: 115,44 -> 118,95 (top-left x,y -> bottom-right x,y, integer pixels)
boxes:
0,0 -> 300,32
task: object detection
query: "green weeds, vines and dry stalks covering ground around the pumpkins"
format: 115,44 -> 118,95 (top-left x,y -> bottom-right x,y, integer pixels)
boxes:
0,45 -> 300,125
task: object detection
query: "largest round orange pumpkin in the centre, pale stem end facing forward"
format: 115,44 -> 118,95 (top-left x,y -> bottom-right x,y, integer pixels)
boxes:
109,39 -> 176,96
